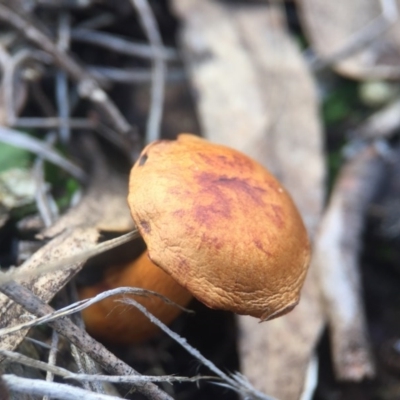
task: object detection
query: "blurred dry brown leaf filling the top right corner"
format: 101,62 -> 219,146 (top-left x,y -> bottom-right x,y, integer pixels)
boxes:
298,0 -> 400,79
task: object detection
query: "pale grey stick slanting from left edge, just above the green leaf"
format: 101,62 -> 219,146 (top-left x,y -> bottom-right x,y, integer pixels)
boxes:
0,126 -> 86,182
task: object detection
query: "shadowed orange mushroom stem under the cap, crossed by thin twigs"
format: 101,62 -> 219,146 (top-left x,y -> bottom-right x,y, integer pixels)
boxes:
78,252 -> 192,345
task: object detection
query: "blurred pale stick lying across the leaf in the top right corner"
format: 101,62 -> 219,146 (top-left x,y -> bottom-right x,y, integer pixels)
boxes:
310,0 -> 399,71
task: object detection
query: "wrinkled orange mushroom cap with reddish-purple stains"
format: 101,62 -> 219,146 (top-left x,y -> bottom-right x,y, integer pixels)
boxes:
128,134 -> 310,320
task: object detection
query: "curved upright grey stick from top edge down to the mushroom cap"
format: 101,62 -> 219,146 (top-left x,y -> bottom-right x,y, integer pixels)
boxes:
131,0 -> 166,143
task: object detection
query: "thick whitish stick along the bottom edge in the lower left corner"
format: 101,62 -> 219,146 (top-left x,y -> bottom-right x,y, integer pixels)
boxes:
2,374 -> 121,400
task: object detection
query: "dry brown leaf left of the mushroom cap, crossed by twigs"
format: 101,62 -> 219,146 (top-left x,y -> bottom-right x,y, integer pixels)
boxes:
0,136 -> 133,350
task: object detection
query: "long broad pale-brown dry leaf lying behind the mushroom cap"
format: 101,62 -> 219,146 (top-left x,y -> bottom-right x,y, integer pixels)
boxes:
173,0 -> 324,400
